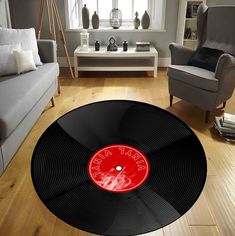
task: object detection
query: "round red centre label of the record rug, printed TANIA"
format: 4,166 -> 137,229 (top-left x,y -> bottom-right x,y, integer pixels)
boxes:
88,145 -> 150,192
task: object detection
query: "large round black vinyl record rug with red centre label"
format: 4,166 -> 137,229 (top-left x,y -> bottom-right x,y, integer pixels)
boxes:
31,100 -> 207,236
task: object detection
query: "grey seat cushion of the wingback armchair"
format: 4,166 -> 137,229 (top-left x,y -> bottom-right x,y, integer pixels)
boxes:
167,65 -> 219,92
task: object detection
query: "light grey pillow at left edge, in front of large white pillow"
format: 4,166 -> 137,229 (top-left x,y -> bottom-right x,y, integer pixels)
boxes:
0,44 -> 21,76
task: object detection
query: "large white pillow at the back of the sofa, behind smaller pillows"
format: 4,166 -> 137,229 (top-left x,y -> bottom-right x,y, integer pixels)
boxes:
0,27 -> 42,66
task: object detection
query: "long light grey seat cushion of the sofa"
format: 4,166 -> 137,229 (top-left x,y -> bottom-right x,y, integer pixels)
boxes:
0,63 -> 59,139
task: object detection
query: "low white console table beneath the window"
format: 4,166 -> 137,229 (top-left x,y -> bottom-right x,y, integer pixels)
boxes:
74,46 -> 158,77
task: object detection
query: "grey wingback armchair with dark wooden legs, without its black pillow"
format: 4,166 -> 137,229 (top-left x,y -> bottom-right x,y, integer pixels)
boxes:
167,4 -> 235,122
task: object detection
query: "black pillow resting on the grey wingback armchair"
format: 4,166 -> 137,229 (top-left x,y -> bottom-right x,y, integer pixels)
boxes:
188,47 -> 224,72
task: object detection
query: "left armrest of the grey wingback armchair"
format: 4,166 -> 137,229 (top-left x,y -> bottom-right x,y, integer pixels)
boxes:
169,43 -> 195,65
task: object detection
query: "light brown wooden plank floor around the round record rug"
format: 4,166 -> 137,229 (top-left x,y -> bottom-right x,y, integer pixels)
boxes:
0,69 -> 235,236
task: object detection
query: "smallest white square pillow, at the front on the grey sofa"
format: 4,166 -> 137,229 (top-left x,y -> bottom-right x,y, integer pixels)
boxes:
13,50 -> 37,74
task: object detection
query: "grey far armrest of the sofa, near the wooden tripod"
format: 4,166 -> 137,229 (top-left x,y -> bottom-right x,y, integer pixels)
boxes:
37,39 -> 57,63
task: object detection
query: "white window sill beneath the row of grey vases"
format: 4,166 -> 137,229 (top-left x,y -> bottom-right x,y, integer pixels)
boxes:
65,28 -> 166,33
